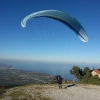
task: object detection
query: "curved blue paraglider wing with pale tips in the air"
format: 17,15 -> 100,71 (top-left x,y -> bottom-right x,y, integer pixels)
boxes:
21,10 -> 88,42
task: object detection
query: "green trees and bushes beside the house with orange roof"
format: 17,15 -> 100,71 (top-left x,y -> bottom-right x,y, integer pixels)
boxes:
70,66 -> 100,84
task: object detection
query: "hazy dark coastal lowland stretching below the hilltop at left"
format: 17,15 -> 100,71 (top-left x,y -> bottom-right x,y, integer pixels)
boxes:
0,63 -> 53,86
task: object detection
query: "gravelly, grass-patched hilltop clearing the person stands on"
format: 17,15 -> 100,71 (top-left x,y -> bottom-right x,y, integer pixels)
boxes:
0,84 -> 100,100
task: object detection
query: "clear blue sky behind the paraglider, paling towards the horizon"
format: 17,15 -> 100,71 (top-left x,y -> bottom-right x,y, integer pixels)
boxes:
0,0 -> 100,64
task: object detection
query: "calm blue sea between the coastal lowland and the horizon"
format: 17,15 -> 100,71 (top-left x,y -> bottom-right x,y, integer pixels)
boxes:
0,61 -> 100,82
